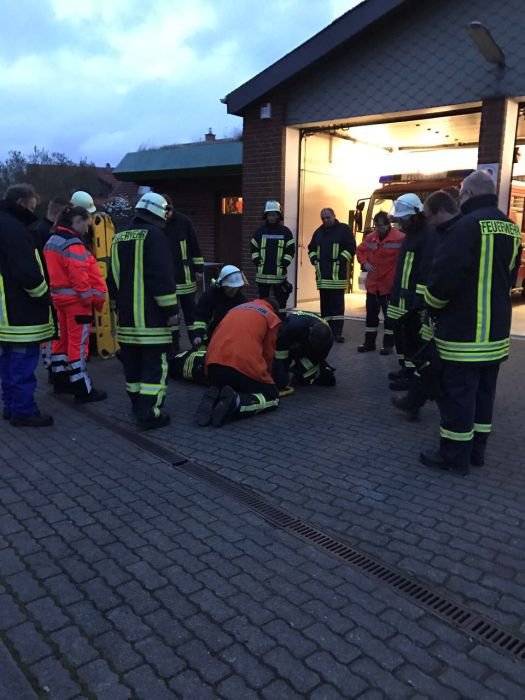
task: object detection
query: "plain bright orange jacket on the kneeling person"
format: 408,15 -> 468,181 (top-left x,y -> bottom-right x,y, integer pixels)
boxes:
206,299 -> 281,384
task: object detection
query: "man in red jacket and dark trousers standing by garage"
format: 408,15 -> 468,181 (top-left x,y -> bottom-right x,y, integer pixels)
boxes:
356,211 -> 405,355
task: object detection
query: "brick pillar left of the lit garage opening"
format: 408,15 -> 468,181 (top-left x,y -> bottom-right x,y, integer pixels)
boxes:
242,91 -> 286,296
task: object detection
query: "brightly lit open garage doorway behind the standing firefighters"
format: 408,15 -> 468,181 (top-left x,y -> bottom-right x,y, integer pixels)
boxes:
297,111 -> 481,317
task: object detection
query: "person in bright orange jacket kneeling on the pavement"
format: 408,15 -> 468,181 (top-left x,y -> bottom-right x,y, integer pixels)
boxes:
196,299 -> 281,427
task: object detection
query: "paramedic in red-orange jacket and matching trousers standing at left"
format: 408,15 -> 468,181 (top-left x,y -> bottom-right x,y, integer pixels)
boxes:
44,206 -> 107,403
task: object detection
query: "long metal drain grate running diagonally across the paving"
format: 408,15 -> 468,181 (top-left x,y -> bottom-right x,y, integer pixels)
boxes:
78,409 -> 525,661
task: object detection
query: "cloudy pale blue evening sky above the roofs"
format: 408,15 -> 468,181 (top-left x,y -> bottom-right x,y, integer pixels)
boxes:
0,0 -> 358,165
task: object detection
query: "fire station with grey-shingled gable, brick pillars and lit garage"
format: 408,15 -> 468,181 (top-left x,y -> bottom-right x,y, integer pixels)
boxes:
224,0 -> 525,312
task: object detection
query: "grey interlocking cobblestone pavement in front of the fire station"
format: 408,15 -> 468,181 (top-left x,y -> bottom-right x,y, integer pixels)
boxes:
0,322 -> 525,700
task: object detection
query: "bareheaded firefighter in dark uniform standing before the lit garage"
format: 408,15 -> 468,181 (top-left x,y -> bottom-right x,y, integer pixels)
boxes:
308,208 -> 355,343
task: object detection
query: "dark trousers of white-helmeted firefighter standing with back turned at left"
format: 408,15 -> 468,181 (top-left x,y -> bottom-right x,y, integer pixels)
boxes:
120,344 -> 168,423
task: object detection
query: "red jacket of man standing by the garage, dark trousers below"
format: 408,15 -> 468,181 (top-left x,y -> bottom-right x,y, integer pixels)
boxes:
356,227 -> 405,295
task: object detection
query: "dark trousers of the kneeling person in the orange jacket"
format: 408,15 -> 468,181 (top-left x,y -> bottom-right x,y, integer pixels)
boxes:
208,364 -> 279,418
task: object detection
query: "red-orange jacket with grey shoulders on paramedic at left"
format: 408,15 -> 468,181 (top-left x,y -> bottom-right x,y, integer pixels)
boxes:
44,226 -> 107,310
